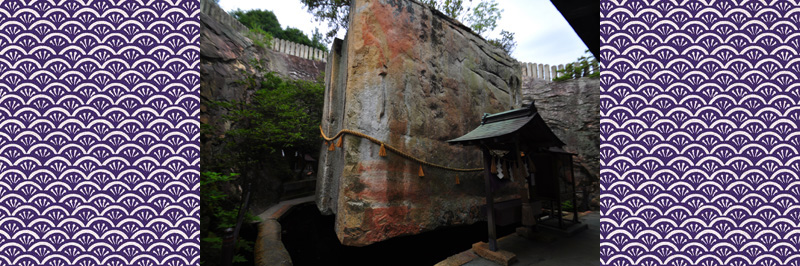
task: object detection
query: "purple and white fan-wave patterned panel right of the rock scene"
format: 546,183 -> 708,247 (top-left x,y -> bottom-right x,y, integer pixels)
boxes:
600,0 -> 800,266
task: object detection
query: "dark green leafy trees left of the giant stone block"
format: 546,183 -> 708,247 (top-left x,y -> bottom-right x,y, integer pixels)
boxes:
200,61 -> 324,265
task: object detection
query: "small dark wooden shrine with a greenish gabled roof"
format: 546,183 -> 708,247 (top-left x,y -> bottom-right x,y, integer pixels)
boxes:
448,103 -> 579,251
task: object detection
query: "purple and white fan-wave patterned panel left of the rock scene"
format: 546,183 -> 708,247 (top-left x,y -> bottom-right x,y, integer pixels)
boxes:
0,0 -> 199,266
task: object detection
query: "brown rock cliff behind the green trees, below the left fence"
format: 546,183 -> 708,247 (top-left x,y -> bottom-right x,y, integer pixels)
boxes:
200,13 -> 325,214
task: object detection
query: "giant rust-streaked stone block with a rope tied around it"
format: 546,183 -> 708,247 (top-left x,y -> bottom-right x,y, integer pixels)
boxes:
317,0 -> 522,246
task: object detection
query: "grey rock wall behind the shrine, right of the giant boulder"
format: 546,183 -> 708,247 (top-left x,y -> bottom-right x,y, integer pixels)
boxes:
522,77 -> 600,208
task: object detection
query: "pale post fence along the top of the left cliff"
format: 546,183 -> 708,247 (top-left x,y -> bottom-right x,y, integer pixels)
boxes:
200,0 -> 328,62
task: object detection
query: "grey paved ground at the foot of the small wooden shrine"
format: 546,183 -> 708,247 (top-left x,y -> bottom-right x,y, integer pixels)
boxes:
437,212 -> 600,266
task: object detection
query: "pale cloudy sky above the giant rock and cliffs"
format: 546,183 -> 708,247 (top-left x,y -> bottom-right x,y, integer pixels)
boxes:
219,0 -> 587,64
